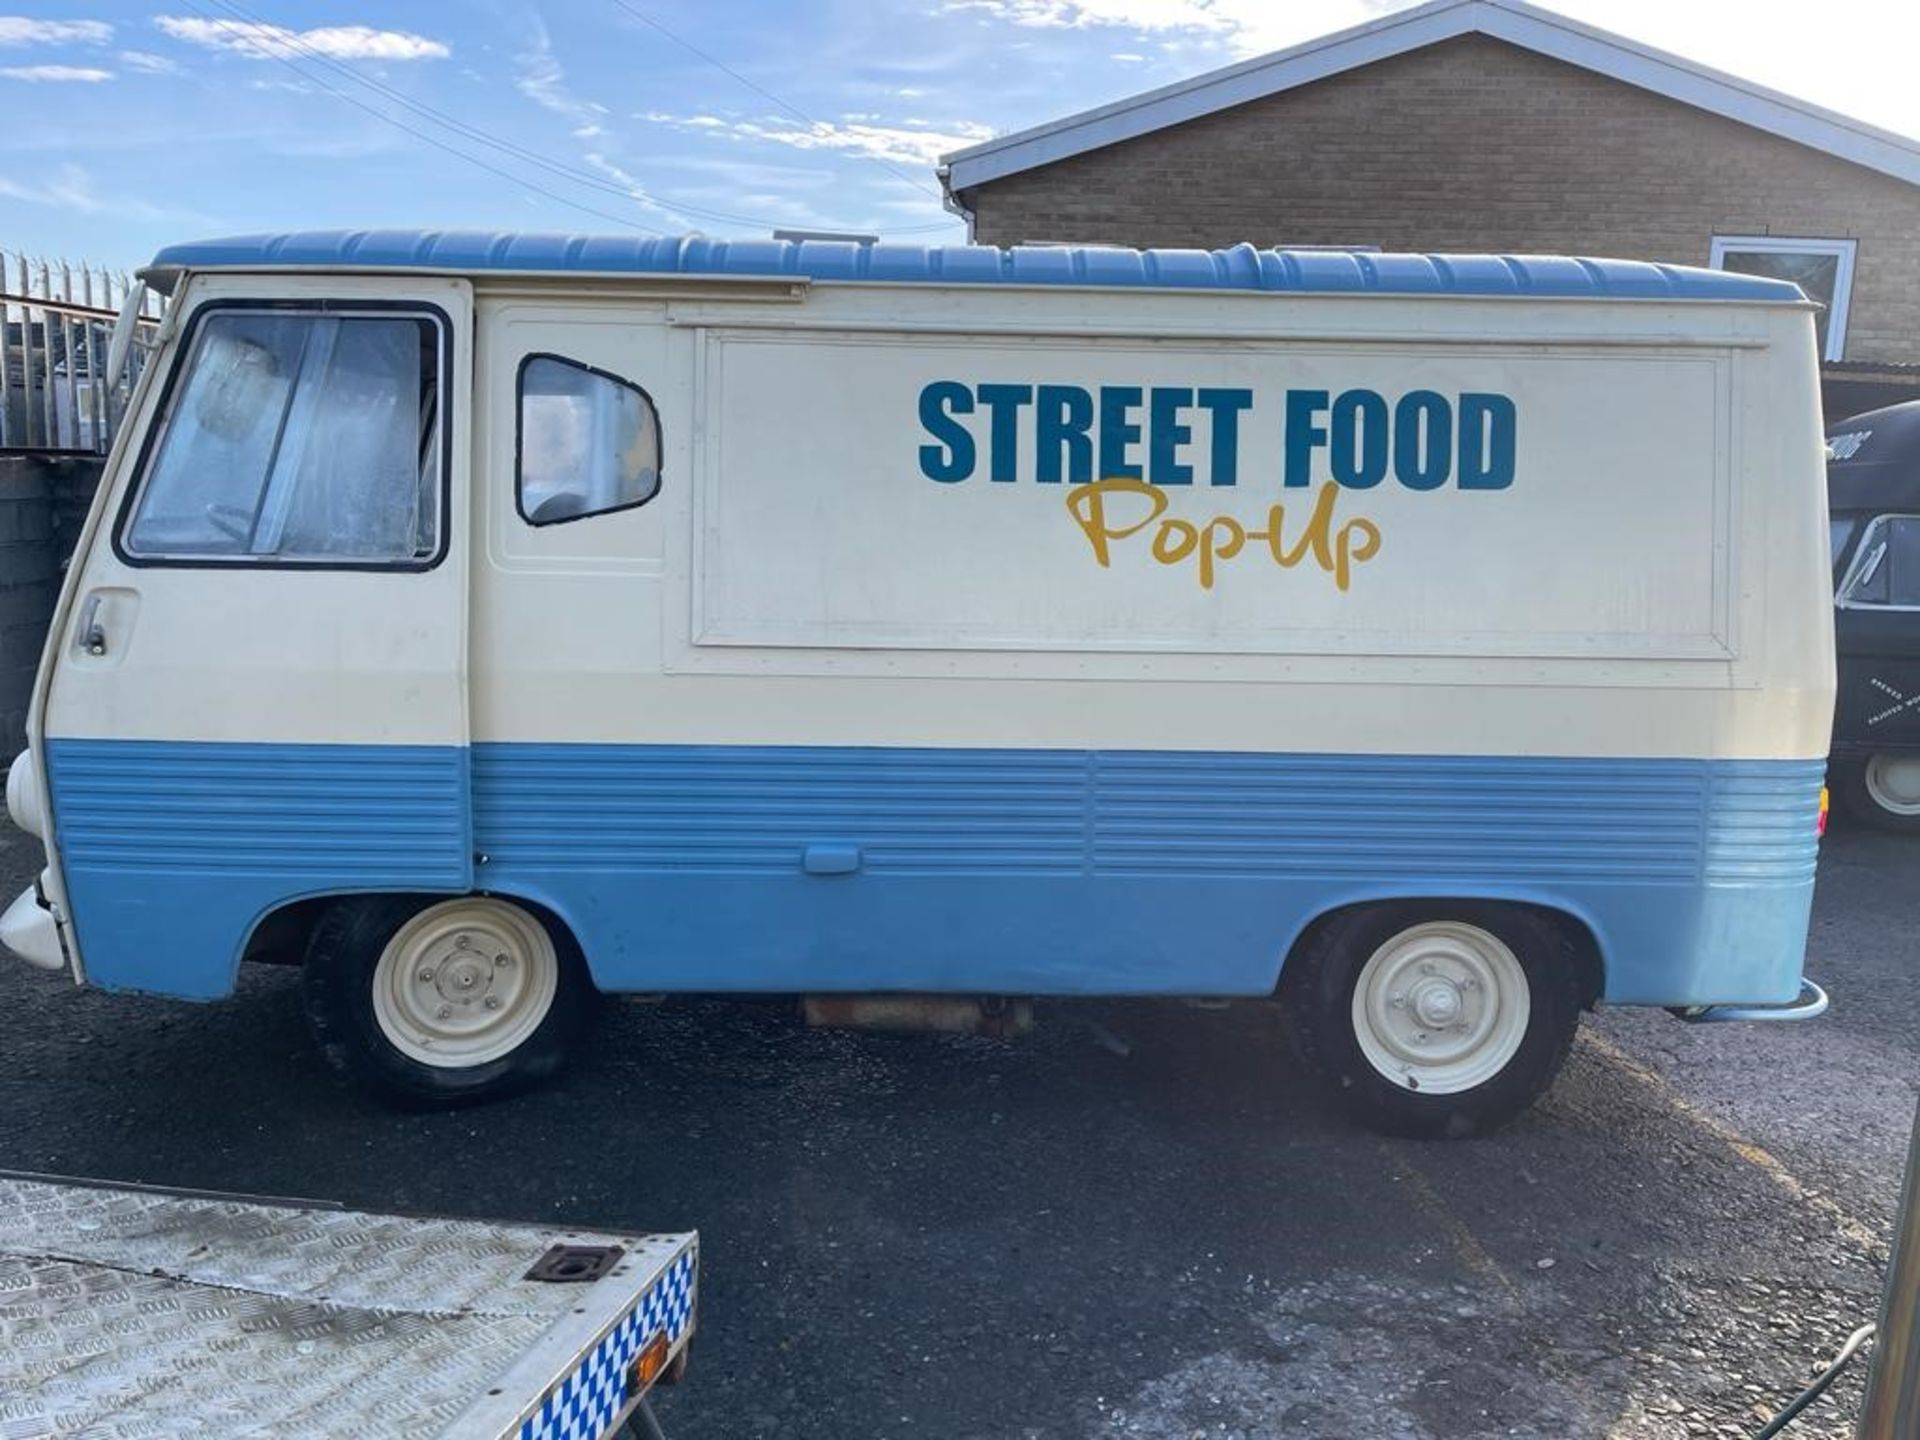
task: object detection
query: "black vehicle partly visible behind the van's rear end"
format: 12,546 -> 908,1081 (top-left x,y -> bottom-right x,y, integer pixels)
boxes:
1826,399 -> 1920,835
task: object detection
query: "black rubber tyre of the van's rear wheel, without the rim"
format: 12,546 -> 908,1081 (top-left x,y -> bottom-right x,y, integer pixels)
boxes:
1281,900 -> 1584,1140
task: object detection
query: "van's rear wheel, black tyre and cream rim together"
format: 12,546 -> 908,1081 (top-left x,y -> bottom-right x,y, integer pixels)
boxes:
1288,902 -> 1580,1139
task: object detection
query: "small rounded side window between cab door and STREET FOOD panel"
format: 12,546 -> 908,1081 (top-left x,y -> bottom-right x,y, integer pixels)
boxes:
515,355 -> 660,524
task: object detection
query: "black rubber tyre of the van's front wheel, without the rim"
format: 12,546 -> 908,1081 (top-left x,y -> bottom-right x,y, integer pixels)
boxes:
303,895 -> 595,1110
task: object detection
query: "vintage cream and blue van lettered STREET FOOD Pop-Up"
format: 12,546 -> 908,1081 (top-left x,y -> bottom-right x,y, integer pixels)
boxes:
4,232 -> 1834,1135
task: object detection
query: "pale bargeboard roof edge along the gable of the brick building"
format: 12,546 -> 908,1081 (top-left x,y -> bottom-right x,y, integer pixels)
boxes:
941,0 -> 1920,196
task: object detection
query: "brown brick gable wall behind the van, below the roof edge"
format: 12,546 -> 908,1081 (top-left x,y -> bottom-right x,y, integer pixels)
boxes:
964,36 -> 1920,361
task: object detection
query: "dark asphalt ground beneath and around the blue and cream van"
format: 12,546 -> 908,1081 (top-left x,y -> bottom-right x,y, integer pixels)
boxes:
0,831 -> 1920,1440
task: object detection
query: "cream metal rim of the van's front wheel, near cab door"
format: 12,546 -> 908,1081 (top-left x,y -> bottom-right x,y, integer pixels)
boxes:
372,897 -> 561,1069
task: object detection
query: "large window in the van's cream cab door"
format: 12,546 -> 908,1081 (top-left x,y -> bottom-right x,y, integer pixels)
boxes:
121,309 -> 444,566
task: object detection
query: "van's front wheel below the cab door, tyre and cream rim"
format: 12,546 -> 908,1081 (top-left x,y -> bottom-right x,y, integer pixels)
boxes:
305,895 -> 593,1106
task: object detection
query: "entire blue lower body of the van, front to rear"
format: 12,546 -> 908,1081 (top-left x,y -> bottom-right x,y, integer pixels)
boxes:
37,741 -> 1822,1004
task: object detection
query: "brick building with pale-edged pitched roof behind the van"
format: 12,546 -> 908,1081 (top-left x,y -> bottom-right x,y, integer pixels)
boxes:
941,0 -> 1920,415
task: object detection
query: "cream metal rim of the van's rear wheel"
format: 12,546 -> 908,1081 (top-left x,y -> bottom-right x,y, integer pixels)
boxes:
1354,920 -> 1532,1094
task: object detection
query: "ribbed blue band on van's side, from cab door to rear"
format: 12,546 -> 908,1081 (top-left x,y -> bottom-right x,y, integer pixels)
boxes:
474,745 -> 1822,883
